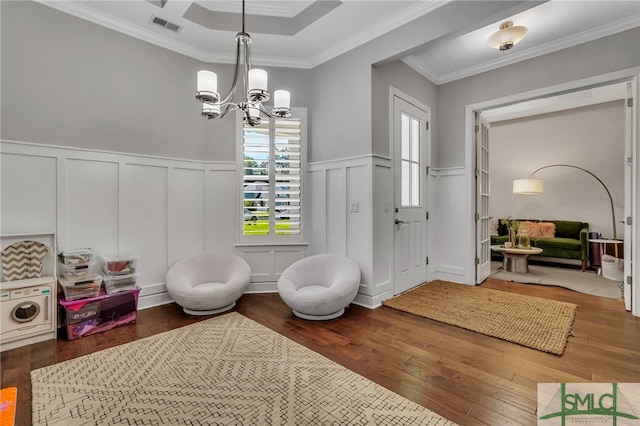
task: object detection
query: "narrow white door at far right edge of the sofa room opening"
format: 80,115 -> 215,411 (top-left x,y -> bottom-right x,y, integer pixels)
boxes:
623,82 -> 637,311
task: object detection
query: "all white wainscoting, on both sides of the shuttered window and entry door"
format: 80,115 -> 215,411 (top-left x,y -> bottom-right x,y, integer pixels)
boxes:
5,141 -> 442,308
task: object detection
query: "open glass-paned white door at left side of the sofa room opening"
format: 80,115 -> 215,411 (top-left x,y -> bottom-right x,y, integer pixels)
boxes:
475,113 -> 491,284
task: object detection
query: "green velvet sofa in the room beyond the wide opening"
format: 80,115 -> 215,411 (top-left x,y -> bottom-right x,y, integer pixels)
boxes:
491,219 -> 589,271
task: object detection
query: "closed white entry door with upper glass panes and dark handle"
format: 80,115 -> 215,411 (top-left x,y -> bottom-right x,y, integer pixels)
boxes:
393,96 -> 428,294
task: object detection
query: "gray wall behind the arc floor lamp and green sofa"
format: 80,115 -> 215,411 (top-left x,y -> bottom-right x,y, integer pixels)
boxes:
489,100 -> 626,238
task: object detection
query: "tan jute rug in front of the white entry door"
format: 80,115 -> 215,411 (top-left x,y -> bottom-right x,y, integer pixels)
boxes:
382,280 -> 578,355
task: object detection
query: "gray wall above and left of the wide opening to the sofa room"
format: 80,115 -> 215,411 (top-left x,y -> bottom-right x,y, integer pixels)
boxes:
434,28 -> 640,168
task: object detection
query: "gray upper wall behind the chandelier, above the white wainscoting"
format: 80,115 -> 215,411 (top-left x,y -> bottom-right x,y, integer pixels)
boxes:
0,1 -> 310,161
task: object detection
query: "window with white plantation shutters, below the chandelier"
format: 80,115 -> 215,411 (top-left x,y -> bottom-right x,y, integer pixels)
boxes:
242,111 -> 304,241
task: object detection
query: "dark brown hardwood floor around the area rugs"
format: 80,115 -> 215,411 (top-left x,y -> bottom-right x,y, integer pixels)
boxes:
1,279 -> 640,426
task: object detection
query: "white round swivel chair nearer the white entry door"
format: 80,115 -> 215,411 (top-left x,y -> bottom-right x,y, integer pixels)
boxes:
278,254 -> 360,320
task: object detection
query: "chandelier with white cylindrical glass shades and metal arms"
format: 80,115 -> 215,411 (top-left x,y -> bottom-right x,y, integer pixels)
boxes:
196,0 -> 291,126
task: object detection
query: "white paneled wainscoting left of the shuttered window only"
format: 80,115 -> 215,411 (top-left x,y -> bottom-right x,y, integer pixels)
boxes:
0,141 -> 239,309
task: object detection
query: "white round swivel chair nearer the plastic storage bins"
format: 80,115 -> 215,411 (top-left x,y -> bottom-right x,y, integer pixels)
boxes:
166,253 -> 251,315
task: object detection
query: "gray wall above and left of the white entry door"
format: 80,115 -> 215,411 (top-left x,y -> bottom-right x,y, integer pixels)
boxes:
371,61 -> 437,157
